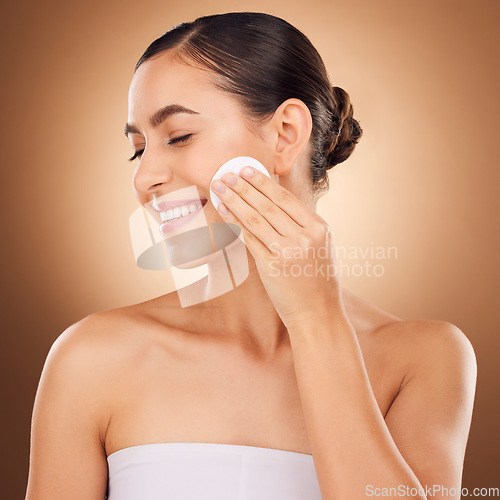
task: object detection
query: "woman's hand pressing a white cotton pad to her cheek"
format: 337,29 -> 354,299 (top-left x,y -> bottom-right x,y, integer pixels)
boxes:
212,166 -> 342,327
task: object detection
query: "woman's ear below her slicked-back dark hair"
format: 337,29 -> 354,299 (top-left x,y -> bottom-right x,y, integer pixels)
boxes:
272,98 -> 312,175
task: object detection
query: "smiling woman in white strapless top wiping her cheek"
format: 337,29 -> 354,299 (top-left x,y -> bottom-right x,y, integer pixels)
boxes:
26,12 -> 476,500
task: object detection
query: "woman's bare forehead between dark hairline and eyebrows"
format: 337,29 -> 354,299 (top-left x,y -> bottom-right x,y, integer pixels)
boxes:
128,52 -> 231,123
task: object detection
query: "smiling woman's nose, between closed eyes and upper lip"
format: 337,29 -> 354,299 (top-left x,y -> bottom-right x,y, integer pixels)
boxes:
132,147 -> 173,205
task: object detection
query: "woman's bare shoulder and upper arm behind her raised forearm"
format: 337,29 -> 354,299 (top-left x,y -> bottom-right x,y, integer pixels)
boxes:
336,292 -> 477,491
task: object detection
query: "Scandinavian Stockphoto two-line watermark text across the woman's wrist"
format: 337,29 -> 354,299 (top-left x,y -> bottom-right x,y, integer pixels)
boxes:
269,241 -> 398,279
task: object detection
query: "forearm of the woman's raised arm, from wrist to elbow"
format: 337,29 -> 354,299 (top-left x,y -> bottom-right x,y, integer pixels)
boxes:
288,308 -> 425,500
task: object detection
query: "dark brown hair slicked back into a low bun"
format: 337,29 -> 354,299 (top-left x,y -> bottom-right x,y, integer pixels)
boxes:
135,12 -> 363,196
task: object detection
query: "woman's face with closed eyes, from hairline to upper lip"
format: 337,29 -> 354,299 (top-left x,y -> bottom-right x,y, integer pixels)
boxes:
127,51 -> 274,226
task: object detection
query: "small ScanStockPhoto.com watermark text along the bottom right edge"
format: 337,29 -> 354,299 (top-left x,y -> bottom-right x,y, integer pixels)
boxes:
365,484 -> 500,498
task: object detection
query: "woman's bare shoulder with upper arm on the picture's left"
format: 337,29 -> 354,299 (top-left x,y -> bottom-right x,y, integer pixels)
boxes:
26,310 -> 162,500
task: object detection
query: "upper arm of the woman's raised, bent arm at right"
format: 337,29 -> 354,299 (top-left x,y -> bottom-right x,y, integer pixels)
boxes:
385,320 -> 477,499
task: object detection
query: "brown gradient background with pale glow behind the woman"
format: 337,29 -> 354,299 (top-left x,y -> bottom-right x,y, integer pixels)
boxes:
0,0 -> 500,499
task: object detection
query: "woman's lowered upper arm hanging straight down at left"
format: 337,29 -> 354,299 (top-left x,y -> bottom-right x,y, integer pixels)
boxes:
26,317 -> 108,500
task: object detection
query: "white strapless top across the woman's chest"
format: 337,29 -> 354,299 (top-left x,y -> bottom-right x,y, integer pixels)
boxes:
106,443 -> 321,500
